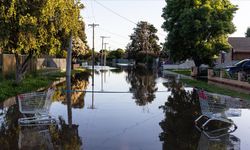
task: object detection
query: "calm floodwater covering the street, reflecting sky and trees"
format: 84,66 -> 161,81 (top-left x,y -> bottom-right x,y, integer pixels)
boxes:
0,68 -> 250,150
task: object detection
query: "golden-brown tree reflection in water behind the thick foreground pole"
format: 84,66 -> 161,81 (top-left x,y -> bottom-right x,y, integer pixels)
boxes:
53,71 -> 90,108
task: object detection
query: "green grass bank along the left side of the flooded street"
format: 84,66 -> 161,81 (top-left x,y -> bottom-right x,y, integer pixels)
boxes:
0,69 -> 84,101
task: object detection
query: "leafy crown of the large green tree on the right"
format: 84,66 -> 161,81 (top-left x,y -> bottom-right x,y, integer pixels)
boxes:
162,0 -> 237,66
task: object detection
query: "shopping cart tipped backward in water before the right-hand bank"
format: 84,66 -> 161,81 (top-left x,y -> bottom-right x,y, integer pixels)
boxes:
195,90 -> 241,138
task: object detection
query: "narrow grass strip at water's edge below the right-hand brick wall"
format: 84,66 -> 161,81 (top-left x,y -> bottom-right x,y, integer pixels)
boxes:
181,79 -> 250,100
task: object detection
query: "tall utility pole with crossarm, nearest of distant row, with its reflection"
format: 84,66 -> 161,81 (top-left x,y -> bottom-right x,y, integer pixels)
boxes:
89,23 -> 99,109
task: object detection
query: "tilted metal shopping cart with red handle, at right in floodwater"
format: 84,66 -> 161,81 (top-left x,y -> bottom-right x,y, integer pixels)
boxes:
195,90 -> 237,138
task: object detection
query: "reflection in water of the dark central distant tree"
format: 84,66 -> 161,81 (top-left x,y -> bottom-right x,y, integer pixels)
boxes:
127,67 -> 157,106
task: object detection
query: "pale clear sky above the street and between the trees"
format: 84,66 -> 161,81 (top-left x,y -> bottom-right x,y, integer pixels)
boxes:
81,0 -> 250,50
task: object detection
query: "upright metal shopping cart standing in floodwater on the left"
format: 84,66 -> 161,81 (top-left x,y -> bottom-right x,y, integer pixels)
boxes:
18,89 -> 56,126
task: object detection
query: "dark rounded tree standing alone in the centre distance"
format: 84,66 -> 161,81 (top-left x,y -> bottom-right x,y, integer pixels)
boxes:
127,21 -> 161,63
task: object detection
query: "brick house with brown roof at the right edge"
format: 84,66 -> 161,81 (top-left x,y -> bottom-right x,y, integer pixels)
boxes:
217,37 -> 250,65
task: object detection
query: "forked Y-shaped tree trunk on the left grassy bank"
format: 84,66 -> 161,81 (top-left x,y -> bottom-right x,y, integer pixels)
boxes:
15,52 -> 33,84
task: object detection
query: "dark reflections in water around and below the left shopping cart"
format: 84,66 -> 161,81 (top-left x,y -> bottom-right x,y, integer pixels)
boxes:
0,104 -> 82,150
